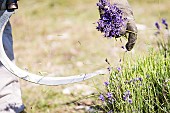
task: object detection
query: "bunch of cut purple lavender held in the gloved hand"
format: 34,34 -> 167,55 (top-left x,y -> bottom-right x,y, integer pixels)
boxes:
96,0 -> 127,38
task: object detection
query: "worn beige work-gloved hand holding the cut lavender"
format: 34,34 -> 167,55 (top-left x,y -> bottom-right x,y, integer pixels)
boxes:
99,0 -> 137,51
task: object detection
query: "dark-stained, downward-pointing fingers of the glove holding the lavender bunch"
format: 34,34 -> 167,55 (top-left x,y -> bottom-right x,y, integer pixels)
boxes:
126,20 -> 137,51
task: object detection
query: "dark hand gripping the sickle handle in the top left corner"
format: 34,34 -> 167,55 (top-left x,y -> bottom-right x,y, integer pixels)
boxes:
0,0 -> 18,10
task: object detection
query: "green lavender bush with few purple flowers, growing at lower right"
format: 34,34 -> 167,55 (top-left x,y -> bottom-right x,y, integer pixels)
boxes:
94,20 -> 170,113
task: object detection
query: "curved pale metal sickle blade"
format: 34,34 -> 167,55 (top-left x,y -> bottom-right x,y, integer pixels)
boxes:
0,11 -> 109,85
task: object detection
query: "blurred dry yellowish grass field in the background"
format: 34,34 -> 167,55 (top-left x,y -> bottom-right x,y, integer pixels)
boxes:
11,0 -> 170,113
